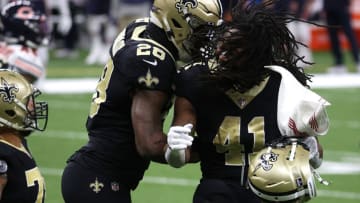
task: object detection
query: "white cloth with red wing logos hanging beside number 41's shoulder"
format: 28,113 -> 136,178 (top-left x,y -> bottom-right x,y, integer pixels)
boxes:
266,66 -> 330,136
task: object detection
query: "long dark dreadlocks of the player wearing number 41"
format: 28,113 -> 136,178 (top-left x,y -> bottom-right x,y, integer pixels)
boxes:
208,0 -> 310,92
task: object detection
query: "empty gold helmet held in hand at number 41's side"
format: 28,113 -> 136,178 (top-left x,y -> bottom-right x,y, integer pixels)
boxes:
248,142 -> 316,202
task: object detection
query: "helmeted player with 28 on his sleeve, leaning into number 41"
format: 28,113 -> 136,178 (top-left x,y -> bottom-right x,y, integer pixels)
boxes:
62,0 -> 222,203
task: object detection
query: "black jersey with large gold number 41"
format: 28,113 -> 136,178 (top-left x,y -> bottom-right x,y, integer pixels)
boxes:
175,65 -> 281,184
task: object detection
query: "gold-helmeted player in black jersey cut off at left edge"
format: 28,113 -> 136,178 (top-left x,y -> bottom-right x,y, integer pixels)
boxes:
0,70 -> 48,203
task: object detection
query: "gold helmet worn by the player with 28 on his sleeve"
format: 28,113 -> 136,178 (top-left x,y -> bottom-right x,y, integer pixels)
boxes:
150,0 -> 223,60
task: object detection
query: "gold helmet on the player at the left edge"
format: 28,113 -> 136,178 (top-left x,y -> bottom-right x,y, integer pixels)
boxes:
0,69 -> 48,131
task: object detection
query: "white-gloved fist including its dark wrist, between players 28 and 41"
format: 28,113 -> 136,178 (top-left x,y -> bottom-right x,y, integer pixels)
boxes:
165,123 -> 194,168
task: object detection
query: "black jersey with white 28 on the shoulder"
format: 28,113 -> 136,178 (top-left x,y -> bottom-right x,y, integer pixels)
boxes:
68,19 -> 177,189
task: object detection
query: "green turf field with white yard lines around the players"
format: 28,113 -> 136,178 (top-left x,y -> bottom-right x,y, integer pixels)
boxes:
29,49 -> 360,203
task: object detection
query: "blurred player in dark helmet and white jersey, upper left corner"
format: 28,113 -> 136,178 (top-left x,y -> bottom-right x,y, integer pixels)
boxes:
0,0 -> 48,84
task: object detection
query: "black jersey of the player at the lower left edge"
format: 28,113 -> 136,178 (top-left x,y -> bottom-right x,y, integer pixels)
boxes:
0,140 -> 45,203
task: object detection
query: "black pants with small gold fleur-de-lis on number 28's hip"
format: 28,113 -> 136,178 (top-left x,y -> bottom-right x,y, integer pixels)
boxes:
61,162 -> 131,203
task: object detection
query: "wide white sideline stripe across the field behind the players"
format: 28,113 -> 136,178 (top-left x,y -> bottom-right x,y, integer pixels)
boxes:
39,73 -> 360,94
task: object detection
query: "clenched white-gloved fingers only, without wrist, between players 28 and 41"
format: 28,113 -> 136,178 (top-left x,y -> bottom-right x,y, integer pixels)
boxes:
167,123 -> 194,150
